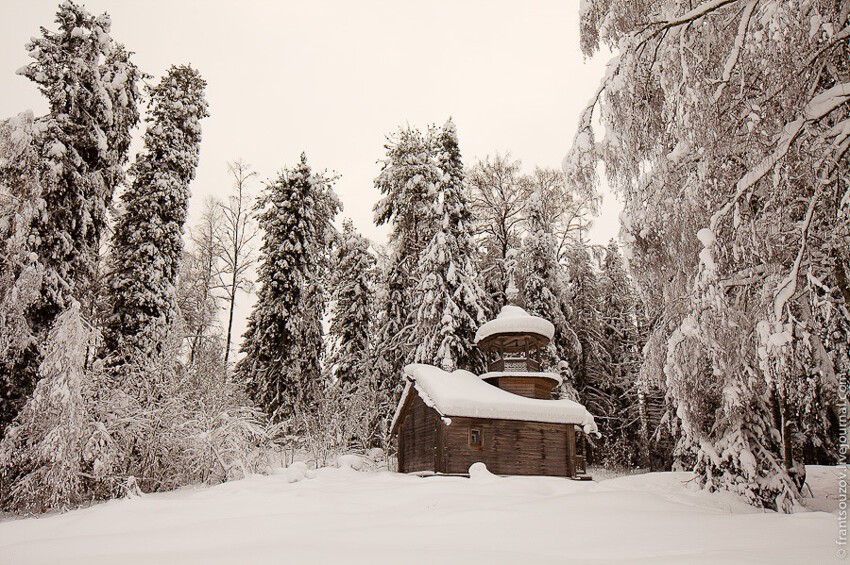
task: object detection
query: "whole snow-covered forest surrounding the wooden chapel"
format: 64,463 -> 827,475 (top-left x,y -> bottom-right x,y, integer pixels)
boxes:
0,0 -> 850,512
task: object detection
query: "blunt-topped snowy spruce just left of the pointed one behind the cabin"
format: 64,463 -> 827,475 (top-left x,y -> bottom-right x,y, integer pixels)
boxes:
375,127 -> 441,392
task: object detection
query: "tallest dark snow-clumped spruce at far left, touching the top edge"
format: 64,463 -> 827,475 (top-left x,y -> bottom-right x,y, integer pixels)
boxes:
0,1 -> 141,430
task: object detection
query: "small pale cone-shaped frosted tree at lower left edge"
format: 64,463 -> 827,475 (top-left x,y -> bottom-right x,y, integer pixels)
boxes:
0,302 -> 117,512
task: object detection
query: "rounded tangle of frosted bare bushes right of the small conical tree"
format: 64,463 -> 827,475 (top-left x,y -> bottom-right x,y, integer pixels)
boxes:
100,338 -> 272,492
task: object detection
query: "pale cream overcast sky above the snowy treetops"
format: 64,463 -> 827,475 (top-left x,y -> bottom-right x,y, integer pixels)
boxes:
0,0 -> 619,348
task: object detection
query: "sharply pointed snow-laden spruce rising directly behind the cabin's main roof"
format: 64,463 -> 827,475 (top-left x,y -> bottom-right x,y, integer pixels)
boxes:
412,119 -> 486,371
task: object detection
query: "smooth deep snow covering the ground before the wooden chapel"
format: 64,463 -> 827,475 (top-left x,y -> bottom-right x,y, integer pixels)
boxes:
0,467 -> 839,565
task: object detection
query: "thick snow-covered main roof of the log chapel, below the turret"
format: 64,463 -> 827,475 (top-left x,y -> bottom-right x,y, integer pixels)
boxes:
391,364 -> 597,434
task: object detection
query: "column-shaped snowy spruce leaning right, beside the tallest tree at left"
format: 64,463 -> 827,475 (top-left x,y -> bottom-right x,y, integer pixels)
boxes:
104,65 -> 207,363
